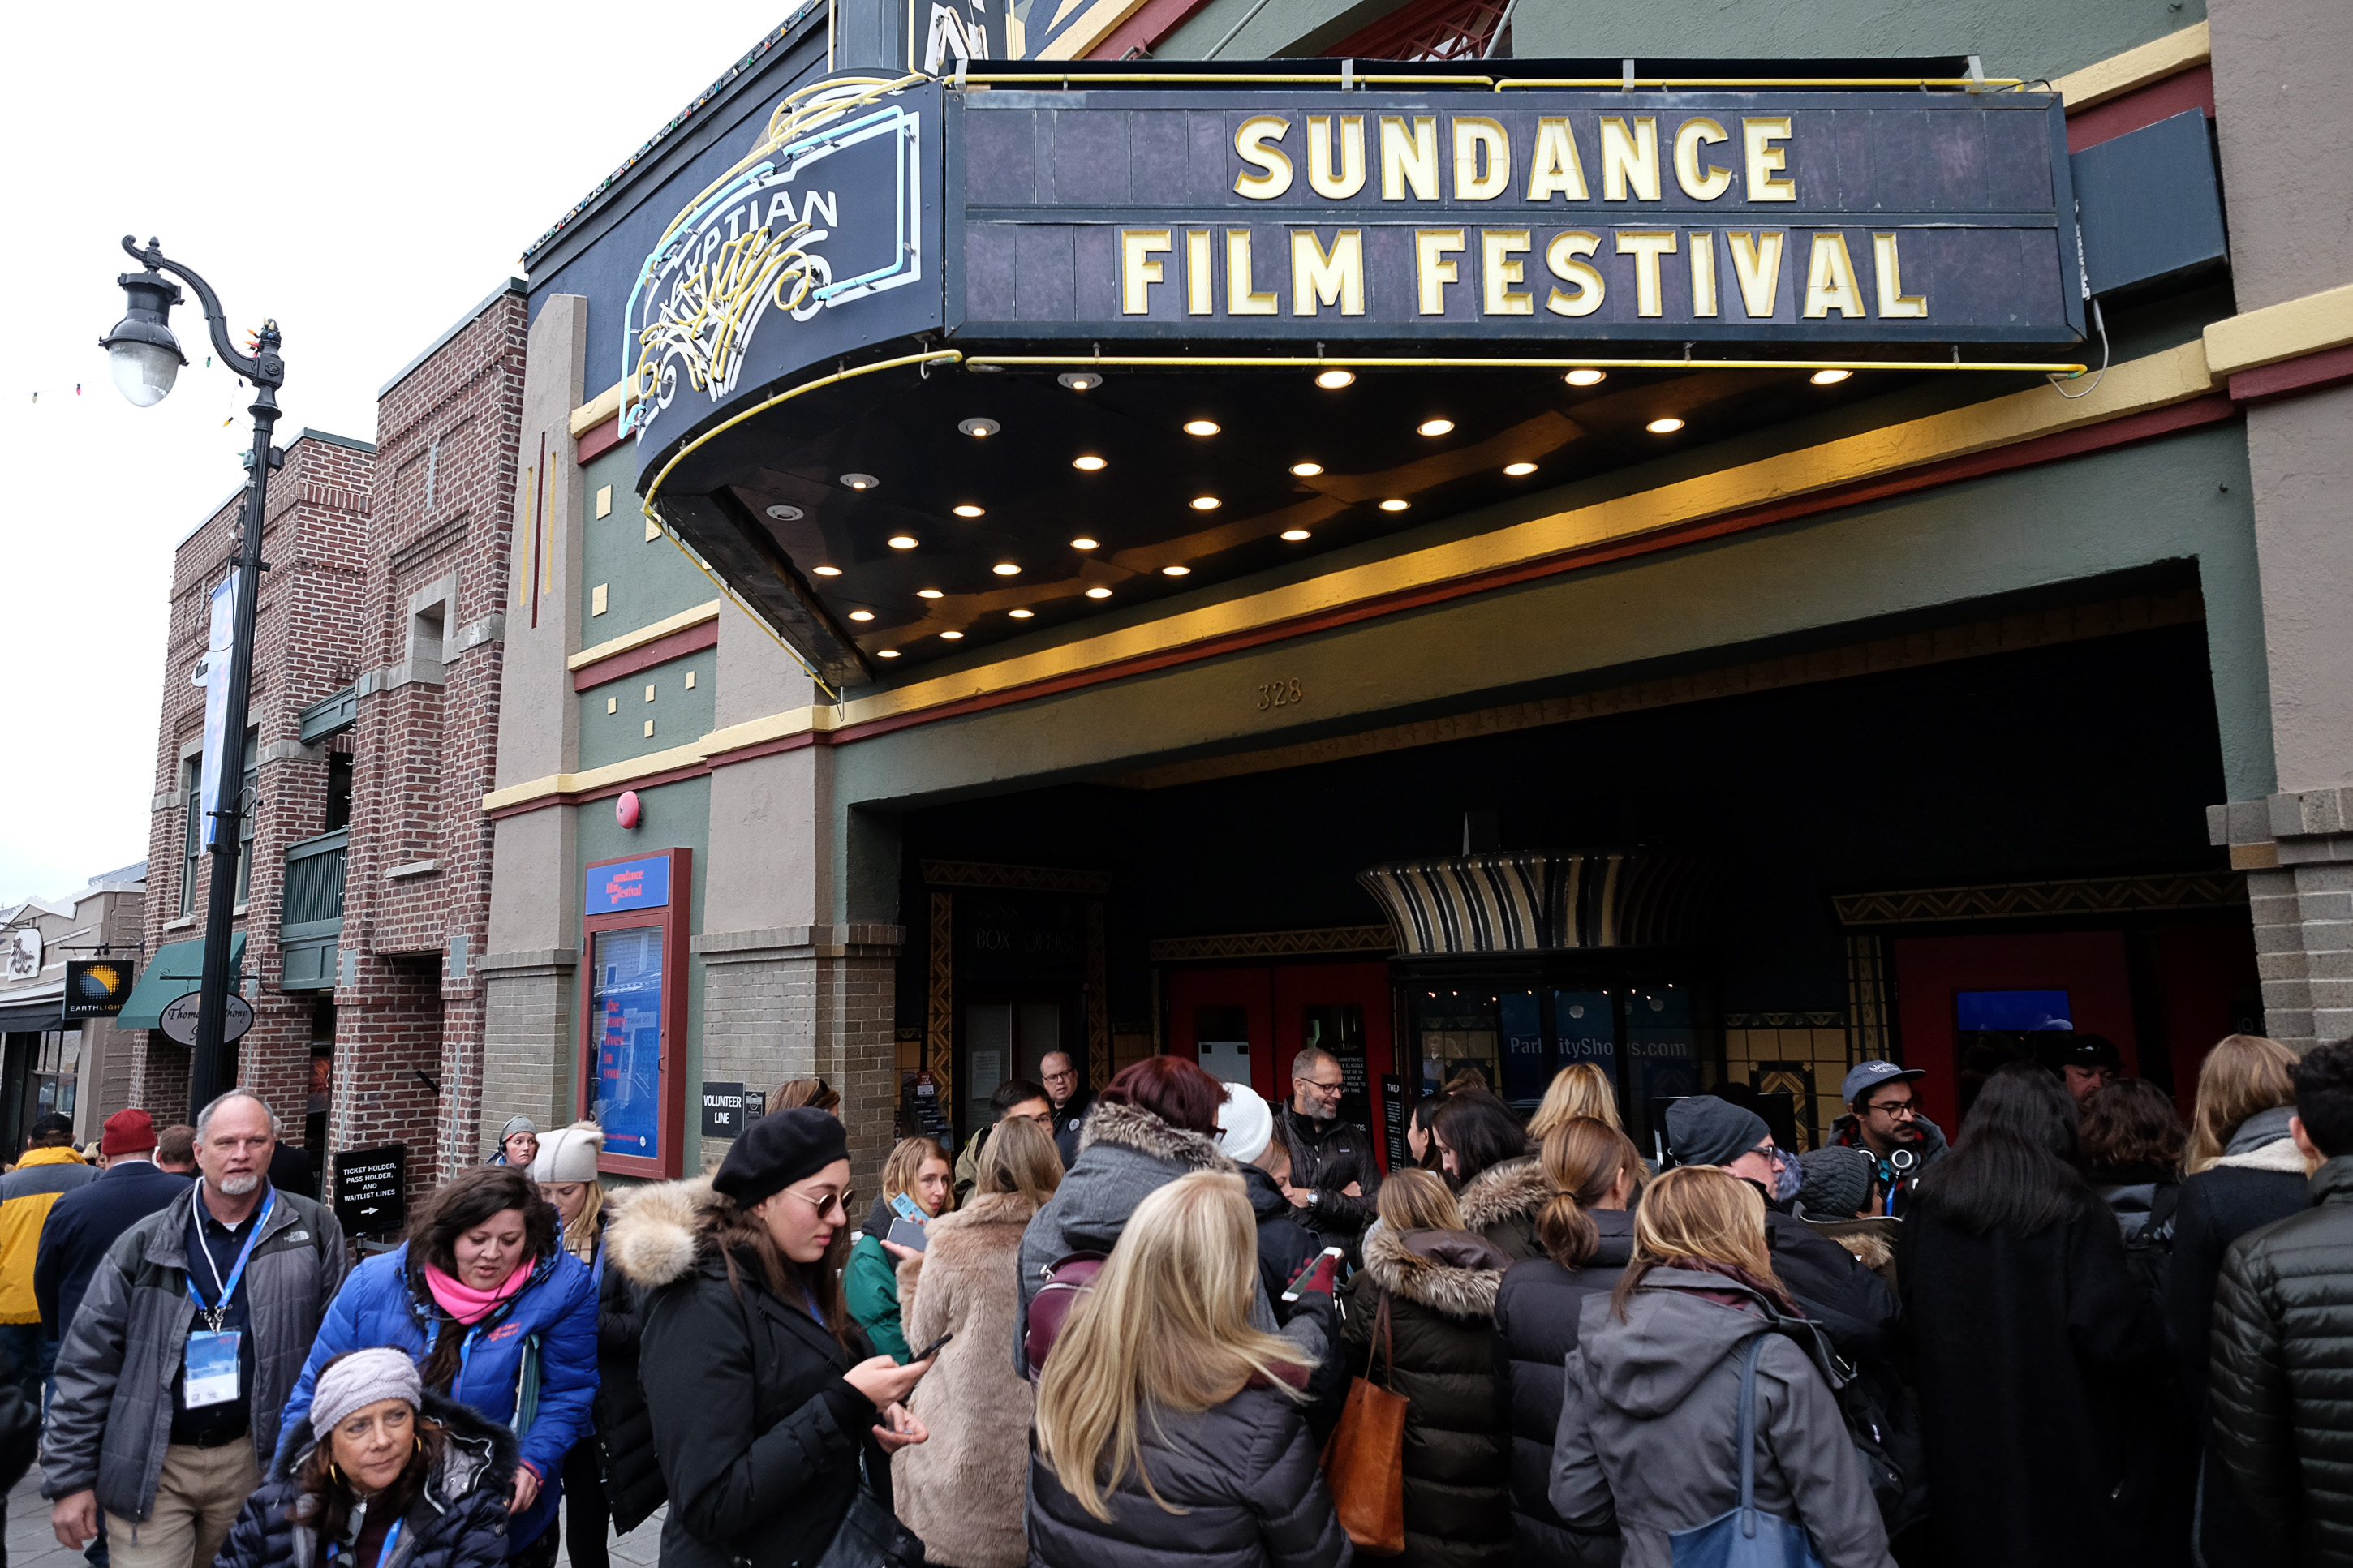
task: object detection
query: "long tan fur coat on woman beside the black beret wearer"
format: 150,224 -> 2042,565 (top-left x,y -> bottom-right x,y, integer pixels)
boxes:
889,1192 -> 1038,1568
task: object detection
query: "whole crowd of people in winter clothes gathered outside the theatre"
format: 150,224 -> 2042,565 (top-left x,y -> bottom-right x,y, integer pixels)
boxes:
0,1034 -> 2353,1568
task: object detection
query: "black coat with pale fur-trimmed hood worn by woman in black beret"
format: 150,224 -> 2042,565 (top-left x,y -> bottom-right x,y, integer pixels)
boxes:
607,1178 -> 889,1568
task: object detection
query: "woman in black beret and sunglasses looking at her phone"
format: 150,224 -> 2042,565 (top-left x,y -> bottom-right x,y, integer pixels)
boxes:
607,1107 -> 931,1568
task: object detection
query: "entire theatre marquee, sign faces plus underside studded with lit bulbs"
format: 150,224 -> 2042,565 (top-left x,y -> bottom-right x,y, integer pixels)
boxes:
600,58 -> 2118,684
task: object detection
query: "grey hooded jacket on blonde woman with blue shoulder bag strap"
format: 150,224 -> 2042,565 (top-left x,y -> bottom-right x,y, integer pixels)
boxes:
1551,1269 -> 1895,1568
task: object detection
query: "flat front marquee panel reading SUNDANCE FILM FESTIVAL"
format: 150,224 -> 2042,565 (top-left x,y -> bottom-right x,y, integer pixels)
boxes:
955,92 -> 2083,343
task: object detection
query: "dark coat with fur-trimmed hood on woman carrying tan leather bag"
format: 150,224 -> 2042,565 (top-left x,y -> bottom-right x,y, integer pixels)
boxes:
1344,1225 -> 1513,1568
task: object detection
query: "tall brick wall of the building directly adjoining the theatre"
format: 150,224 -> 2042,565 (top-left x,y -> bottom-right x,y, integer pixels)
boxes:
332,291 -> 527,1194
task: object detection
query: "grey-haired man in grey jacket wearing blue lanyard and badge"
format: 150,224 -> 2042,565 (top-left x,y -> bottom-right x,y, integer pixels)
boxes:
40,1089 -> 343,1568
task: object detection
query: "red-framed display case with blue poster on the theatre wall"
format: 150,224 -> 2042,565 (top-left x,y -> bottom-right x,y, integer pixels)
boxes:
579,848 -> 695,1178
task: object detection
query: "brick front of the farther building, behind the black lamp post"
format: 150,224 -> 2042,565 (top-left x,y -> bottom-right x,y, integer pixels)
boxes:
130,430 -> 374,1141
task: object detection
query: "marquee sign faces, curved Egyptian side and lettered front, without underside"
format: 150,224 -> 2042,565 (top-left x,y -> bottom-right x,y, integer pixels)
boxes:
619,78 -> 2084,470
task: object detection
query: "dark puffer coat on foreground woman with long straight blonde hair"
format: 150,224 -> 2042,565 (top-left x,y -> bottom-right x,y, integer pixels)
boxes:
1026,1387 -> 1353,1568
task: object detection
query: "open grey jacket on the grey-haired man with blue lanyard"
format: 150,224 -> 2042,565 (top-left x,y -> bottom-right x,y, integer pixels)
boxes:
40,1183 -> 346,1519
